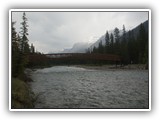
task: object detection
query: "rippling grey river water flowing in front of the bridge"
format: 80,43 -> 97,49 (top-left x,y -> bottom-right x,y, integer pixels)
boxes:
31,66 -> 149,109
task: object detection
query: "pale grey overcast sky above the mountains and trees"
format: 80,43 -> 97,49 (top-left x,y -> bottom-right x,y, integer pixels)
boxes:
12,12 -> 148,53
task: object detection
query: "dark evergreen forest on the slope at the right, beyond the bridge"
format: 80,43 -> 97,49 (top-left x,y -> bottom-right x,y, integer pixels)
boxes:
87,23 -> 148,64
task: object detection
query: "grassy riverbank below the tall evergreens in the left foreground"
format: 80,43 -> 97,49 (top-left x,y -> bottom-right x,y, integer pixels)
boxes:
11,69 -> 37,109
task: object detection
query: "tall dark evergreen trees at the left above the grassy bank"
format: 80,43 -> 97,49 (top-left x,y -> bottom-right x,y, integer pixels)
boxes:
11,12 -> 35,77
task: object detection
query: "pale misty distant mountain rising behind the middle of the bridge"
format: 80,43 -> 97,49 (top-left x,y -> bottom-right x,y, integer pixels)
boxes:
62,42 -> 91,53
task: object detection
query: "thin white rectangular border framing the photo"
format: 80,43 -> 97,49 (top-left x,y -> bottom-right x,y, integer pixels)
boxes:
9,9 -> 152,111
